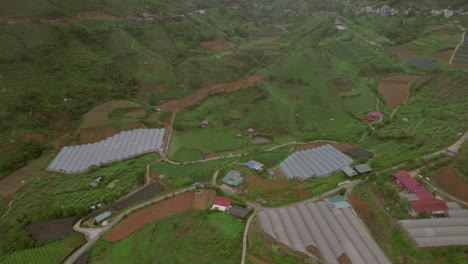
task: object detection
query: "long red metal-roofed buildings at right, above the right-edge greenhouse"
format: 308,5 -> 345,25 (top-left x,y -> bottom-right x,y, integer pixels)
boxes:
393,171 -> 448,213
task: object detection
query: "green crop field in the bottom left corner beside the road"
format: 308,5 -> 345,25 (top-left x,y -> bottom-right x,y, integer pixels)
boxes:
0,233 -> 86,264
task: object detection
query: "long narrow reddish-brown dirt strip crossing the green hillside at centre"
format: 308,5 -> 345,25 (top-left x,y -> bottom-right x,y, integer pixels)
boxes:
160,75 -> 262,111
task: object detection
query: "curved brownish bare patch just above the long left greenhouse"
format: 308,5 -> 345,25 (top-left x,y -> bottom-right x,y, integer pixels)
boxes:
81,100 -> 140,128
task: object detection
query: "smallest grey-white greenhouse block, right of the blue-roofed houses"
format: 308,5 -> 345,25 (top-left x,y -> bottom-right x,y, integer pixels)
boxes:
279,145 -> 353,179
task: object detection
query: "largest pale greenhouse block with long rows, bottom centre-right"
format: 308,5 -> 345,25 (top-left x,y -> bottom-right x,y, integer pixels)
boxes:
258,200 -> 390,264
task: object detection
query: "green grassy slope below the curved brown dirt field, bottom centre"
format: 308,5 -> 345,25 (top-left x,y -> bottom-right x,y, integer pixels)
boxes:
90,211 -> 244,263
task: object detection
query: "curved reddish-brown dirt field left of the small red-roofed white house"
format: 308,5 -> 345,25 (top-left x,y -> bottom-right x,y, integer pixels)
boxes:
104,189 -> 214,242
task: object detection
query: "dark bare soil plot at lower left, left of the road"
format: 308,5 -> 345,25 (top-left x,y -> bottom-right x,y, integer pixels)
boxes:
26,217 -> 78,242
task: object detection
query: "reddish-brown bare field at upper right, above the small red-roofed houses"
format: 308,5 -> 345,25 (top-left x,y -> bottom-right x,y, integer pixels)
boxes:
378,75 -> 424,107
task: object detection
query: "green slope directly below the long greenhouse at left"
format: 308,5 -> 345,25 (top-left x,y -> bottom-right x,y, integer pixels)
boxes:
0,155 -> 155,255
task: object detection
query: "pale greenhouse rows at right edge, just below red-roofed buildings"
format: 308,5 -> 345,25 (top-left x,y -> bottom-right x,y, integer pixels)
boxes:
398,202 -> 468,248
